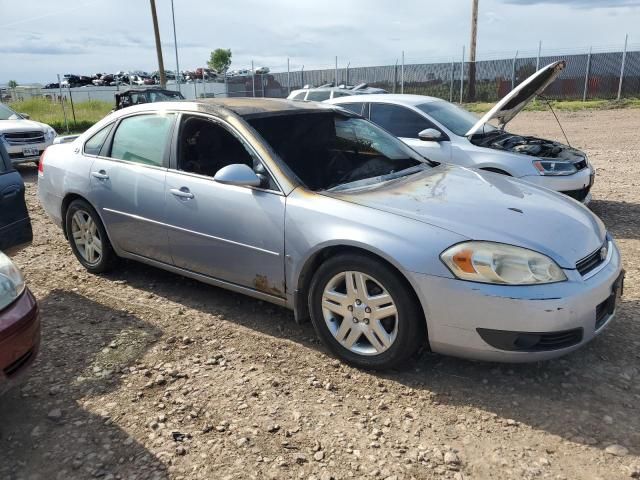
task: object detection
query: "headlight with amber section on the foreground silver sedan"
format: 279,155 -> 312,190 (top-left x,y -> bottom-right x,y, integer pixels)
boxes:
440,241 -> 567,285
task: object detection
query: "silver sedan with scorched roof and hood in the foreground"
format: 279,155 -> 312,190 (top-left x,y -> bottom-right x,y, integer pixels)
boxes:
38,98 -> 624,368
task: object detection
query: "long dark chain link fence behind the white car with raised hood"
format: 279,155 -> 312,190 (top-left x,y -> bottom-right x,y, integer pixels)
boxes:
227,46 -> 640,102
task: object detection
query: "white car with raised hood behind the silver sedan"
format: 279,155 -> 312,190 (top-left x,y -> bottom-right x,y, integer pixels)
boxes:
329,61 -> 595,203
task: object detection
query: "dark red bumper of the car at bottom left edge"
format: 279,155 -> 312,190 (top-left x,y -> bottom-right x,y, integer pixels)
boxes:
0,289 -> 40,394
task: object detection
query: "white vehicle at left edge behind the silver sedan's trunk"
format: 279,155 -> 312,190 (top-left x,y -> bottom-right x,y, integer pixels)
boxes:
0,104 -> 56,165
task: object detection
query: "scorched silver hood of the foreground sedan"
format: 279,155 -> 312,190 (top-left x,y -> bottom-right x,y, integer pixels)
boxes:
324,165 -> 606,269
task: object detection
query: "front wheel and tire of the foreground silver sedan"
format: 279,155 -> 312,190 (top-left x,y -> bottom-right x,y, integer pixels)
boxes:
309,254 -> 426,370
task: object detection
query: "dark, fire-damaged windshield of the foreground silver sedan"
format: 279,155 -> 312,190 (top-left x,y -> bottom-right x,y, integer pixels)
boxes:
247,111 -> 430,190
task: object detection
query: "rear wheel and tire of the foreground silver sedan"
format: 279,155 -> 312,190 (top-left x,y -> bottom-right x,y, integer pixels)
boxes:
65,199 -> 116,273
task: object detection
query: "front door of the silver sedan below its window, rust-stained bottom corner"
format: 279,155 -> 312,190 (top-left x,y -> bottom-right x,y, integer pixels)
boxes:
165,170 -> 285,297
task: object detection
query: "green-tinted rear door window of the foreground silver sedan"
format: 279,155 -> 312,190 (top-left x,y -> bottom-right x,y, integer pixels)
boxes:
109,114 -> 175,167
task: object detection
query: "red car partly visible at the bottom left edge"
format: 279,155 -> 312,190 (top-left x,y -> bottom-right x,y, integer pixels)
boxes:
0,252 -> 40,395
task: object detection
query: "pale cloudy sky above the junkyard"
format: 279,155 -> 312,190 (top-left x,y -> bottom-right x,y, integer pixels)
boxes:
0,0 -> 640,83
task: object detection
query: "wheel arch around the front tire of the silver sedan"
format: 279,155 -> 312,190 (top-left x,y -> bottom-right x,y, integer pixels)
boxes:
293,243 -> 428,344
